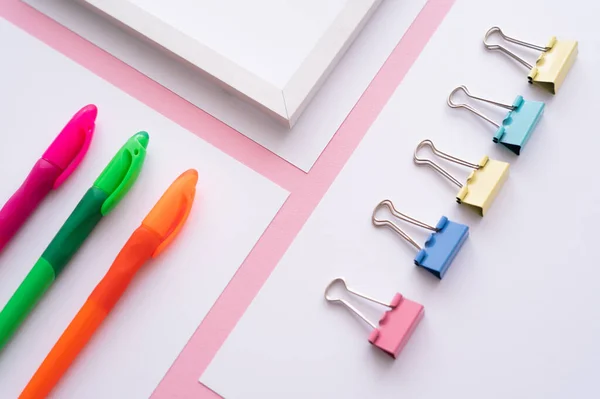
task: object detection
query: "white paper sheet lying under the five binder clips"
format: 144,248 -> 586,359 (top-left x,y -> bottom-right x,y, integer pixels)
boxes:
200,0 -> 600,399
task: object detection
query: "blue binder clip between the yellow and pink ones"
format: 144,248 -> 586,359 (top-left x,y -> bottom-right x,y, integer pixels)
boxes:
372,199 -> 469,280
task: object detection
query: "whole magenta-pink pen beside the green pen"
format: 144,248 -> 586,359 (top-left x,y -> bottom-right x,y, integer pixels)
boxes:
0,105 -> 98,252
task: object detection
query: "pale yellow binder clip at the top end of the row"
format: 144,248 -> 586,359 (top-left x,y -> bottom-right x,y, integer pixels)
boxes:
483,26 -> 577,94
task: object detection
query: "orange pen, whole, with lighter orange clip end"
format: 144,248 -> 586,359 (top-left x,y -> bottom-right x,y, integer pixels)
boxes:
19,169 -> 198,399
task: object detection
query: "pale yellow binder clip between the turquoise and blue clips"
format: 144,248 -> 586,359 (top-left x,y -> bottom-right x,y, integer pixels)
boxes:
413,140 -> 509,216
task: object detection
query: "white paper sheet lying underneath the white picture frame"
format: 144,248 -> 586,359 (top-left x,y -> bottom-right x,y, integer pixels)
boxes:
25,0 -> 426,171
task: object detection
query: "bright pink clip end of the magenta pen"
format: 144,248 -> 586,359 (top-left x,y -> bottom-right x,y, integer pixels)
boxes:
42,104 -> 98,189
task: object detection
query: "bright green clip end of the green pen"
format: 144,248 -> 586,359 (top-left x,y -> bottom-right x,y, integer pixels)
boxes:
94,132 -> 150,216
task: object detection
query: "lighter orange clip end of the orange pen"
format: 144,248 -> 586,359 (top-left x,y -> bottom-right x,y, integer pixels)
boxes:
142,169 -> 198,258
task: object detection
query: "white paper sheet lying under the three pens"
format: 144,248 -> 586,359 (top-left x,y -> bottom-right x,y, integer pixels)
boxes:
0,20 -> 288,399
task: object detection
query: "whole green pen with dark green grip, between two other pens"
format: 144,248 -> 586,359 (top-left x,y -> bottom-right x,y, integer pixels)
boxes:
0,132 -> 149,350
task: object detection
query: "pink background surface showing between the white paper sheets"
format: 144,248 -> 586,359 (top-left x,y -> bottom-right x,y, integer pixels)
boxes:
0,0 -> 454,399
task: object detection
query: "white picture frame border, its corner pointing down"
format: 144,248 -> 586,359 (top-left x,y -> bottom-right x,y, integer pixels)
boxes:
79,0 -> 382,128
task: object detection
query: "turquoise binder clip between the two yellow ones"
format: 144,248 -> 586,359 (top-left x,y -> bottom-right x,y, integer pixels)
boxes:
448,86 -> 544,155
